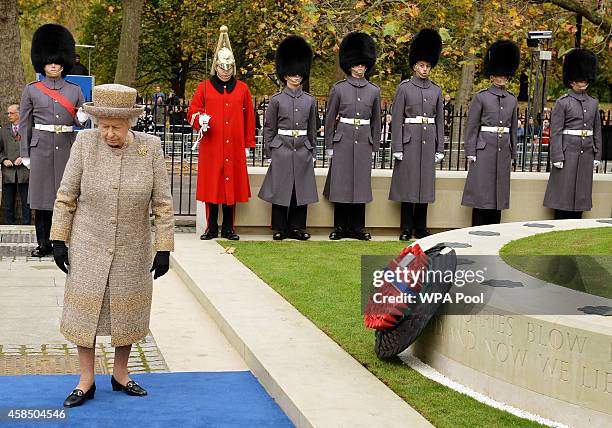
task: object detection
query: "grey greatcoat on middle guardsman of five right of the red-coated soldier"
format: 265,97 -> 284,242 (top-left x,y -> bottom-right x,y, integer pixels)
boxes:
389,76 -> 444,204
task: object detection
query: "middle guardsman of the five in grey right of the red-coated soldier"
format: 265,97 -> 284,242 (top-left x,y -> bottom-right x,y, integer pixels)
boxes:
389,28 -> 444,241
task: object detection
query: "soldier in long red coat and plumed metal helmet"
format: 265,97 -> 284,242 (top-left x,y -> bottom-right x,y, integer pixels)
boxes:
187,25 -> 255,240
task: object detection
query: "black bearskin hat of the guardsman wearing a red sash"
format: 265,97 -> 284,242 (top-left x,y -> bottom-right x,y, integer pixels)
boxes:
30,24 -> 75,77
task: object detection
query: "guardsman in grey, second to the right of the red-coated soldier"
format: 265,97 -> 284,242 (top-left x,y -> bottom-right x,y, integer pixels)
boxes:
323,32 -> 381,241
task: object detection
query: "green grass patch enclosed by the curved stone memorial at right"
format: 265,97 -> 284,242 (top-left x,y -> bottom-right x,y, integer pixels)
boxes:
500,227 -> 612,299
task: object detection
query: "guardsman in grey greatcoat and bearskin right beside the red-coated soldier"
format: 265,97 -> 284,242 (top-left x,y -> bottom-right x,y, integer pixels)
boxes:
259,36 -> 319,241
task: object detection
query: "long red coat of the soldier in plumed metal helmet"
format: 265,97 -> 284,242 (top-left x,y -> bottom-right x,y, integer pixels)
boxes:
187,80 -> 255,205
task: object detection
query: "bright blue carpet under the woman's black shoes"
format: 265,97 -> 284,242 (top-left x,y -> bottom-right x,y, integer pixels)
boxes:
0,372 -> 293,428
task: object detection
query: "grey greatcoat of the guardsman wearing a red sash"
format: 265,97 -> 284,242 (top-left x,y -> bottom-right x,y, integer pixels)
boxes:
19,77 -> 85,211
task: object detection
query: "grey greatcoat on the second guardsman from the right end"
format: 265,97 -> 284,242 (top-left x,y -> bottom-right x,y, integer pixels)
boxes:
461,86 -> 517,210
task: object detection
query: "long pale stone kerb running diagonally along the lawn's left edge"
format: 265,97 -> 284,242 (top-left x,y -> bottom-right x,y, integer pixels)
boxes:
172,234 -> 431,427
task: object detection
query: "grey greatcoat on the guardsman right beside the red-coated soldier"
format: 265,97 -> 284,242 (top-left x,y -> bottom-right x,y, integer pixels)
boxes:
259,87 -> 319,207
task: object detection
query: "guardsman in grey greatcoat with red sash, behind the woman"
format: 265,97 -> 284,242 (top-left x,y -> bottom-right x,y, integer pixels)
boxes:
19,24 -> 87,257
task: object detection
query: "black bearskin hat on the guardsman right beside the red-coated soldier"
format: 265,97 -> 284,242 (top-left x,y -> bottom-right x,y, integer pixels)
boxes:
275,36 -> 312,81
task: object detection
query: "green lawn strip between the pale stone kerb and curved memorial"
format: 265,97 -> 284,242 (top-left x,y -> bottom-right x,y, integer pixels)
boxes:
221,241 -> 539,427
